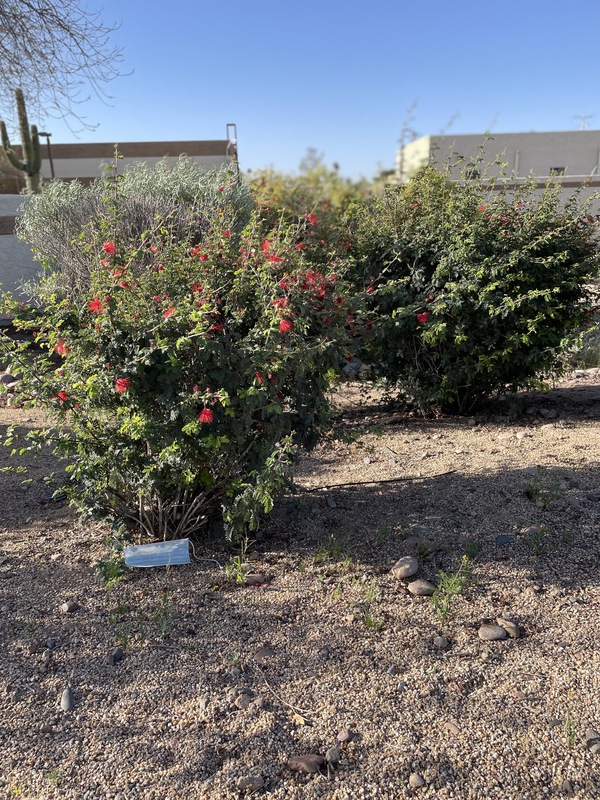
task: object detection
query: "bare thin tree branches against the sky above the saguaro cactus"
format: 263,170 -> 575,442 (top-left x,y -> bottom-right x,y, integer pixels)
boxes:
0,0 -> 122,128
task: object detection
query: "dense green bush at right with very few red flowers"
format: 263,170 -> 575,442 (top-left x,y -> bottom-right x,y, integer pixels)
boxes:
351,168 -> 598,412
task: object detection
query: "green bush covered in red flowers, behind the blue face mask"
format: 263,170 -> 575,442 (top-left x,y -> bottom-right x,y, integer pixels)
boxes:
4,183 -> 347,538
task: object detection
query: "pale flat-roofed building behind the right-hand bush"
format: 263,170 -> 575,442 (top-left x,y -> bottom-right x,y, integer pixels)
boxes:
396,131 -> 600,205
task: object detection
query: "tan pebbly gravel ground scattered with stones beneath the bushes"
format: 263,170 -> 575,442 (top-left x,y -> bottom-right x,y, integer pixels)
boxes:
0,370 -> 600,800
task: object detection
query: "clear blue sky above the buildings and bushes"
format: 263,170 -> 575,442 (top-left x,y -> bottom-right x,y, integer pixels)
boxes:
30,0 -> 600,178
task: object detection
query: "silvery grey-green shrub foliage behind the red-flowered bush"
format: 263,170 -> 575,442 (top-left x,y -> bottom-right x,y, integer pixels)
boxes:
16,157 -> 253,300
